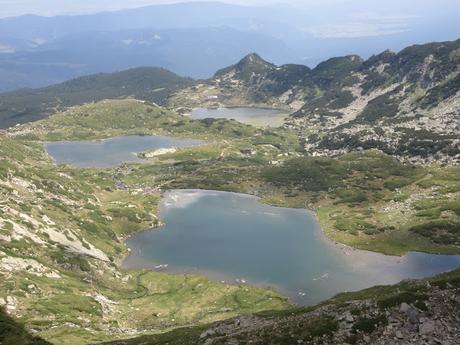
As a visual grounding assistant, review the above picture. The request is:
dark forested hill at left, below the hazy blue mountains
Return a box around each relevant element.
[0,67,193,128]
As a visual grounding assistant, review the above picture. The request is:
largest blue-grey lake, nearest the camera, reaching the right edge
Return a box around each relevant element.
[124,190,460,305]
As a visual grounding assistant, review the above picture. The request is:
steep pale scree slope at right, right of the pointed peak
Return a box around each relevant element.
[296,40,460,162]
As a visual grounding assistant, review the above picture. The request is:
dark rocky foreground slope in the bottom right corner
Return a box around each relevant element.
[195,287,460,345]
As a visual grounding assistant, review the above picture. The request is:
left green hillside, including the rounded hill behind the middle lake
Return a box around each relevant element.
[0,100,298,345]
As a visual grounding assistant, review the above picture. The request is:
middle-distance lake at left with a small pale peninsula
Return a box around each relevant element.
[44,135,203,168]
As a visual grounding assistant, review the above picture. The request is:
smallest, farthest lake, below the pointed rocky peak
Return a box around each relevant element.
[190,108,288,127]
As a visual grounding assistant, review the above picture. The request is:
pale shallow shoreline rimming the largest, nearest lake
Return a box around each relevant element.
[121,189,460,306]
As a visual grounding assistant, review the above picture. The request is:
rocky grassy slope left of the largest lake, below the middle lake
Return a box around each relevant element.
[0,132,288,344]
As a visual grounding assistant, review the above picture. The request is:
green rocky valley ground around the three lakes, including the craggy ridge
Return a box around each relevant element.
[0,41,460,345]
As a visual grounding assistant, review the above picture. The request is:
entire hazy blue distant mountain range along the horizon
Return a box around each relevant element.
[0,2,460,91]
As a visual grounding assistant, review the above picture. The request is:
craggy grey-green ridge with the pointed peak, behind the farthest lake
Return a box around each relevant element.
[169,40,460,162]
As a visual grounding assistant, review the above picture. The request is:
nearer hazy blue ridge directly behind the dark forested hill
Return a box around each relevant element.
[0,28,287,91]
